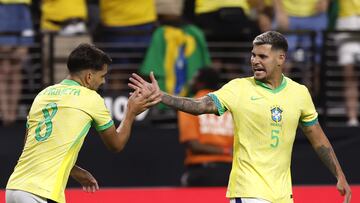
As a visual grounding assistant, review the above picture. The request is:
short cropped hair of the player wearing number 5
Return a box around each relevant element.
[253,31,288,52]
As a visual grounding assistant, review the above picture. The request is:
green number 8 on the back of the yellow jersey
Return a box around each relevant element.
[35,103,58,142]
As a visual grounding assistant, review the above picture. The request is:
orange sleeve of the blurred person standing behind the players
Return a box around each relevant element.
[178,112,200,143]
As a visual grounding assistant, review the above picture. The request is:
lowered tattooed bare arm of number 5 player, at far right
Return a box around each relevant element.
[302,123,351,203]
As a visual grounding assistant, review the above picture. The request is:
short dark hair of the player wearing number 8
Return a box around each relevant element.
[67,43,112,73]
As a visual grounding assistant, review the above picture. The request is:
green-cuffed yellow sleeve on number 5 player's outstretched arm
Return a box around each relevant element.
[208,80,240,115]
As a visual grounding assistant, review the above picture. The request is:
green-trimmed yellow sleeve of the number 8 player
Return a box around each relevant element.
[89,94,114,131]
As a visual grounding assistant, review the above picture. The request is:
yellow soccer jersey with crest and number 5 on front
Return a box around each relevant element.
[209,77,317,203]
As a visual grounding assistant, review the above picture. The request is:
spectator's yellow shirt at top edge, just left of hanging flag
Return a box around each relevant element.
[100,0,156,26]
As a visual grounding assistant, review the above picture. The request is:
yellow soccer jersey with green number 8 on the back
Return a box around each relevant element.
[6,80,113,203]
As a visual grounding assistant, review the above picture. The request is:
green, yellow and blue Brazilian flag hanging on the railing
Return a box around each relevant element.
[140,25,211,96]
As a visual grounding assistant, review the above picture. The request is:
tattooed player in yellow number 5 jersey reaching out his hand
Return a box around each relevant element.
[129,31,351,203]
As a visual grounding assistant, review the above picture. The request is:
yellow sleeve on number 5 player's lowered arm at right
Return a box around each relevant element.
[300,86,318,126]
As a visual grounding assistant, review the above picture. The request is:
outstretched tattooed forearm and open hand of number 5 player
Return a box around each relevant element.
[128,72,218,115]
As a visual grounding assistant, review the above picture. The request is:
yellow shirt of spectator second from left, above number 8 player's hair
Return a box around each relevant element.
[41,0,87,31]
